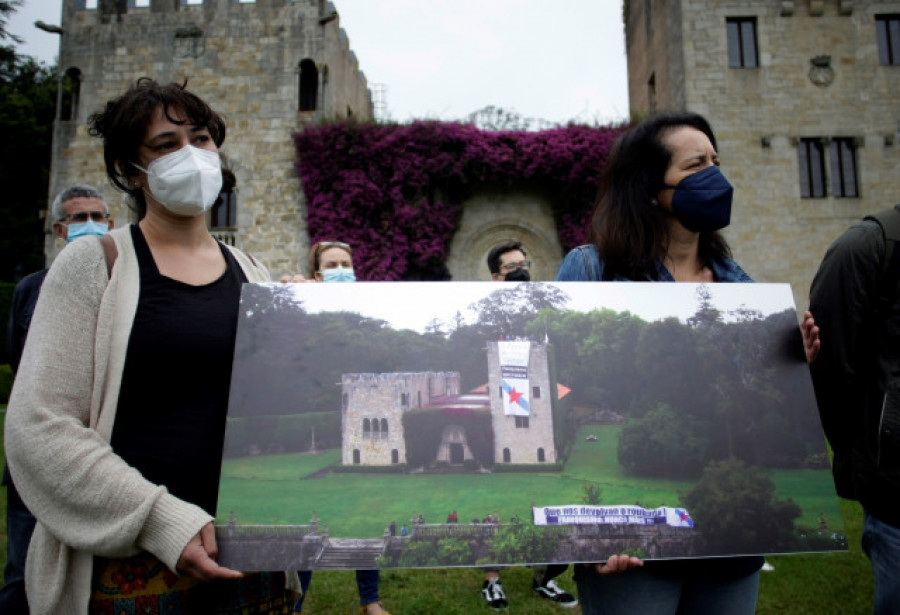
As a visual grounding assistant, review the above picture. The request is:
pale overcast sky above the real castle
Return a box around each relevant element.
[10,0,628,124]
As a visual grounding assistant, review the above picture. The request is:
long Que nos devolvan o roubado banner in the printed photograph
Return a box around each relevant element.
[531,504,694,527]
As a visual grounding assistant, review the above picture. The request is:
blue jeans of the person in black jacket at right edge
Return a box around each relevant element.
[862,509,900,615]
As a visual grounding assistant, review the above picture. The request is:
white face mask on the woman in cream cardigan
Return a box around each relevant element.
[134,145,222,217]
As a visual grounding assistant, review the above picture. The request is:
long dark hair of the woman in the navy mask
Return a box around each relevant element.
[588,113,731,279]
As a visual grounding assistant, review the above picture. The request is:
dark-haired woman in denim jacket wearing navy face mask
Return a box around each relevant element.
[556,113,763,615]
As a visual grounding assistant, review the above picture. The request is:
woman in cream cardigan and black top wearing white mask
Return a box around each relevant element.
[6,79,299,613]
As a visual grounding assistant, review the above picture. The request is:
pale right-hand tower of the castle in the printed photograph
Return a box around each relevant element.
[487,342,557,464]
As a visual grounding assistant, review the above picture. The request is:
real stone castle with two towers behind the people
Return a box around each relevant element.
[46,0,900,298]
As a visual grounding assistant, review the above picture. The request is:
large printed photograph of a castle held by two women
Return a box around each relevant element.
[216,282,847,570]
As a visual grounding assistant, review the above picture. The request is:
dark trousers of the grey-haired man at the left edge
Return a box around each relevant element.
[0,481,35,615]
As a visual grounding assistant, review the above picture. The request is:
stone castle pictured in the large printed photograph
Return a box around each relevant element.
[341,342,558,467]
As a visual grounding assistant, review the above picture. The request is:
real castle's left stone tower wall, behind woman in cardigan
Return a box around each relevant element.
[46,0,372,275]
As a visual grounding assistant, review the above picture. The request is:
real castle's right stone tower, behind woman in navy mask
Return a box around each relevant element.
[624,0,900,309]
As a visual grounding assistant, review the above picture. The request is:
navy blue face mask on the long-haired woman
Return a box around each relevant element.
[665,165,734,233]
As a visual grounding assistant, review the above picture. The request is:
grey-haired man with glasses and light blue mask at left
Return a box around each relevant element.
[0,185,113,615]
